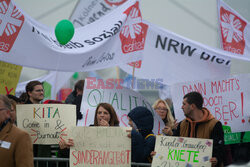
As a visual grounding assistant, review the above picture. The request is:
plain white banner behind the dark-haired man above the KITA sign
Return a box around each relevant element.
[15,71,73,101]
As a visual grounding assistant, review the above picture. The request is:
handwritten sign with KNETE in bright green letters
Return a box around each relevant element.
[152,136,213,167]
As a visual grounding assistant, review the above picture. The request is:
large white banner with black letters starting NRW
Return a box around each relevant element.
[120,21,250,85]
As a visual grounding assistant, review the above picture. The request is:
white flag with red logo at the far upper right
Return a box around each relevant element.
[217,0,250,55]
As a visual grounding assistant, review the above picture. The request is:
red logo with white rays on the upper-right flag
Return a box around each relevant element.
[220,7,247,54]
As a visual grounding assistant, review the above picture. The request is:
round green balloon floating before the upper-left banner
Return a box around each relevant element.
[55,20,75,45]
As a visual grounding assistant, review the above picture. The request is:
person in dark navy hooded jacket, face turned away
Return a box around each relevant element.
[128,107,155,163]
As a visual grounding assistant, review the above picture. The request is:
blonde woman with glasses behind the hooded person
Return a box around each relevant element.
[152,99,178,135]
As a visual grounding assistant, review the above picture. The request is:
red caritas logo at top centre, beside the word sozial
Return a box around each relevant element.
[120,2,148,53]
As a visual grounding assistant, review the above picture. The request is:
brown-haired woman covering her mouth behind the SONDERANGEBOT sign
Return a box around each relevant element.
[59,103,119,149]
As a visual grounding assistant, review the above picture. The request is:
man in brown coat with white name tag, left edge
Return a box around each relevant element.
[0,95,34,167]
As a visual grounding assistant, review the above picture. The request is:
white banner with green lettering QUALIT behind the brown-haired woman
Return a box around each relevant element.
[78,78,165,134]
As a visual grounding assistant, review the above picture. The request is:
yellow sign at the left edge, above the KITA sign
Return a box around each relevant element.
[0,61,22,95]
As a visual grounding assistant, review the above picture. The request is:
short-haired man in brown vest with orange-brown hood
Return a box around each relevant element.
[173,92,224,167]
